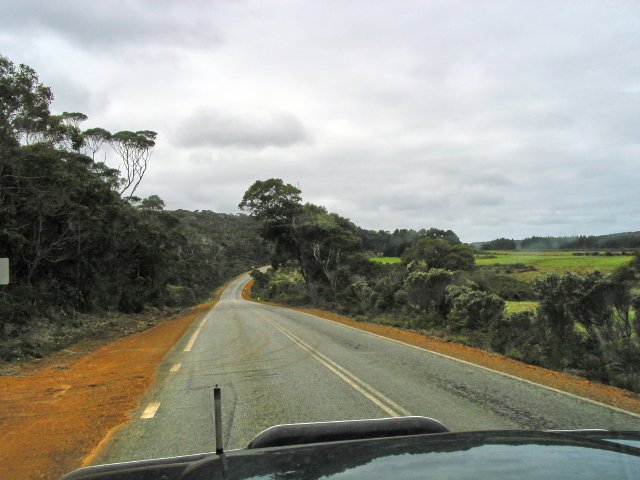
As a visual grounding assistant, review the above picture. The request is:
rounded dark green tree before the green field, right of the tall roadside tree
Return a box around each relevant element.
[402,236,475,270]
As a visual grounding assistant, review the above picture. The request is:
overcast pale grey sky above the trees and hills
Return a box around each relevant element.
[0,0,640,241]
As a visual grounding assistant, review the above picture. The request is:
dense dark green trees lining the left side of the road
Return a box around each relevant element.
[0,56,266,355]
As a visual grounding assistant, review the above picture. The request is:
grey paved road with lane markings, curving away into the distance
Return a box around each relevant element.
[96,276,640,463]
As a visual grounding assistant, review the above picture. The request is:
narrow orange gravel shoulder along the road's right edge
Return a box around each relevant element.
[242,281,640,414]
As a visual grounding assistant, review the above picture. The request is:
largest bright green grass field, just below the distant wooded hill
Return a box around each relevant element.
[476,251,633,281]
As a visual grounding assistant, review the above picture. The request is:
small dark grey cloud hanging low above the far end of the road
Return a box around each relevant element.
[173,110,311,149]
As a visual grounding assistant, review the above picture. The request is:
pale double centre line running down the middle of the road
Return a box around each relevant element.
[255,312,411,417]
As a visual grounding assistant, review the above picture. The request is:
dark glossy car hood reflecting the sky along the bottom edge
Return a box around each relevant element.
[63,431,640,480]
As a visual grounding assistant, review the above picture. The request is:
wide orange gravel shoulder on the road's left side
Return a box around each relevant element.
[0,292,222,480]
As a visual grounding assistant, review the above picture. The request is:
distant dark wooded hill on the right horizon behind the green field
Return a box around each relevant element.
[471,232,640,250]
